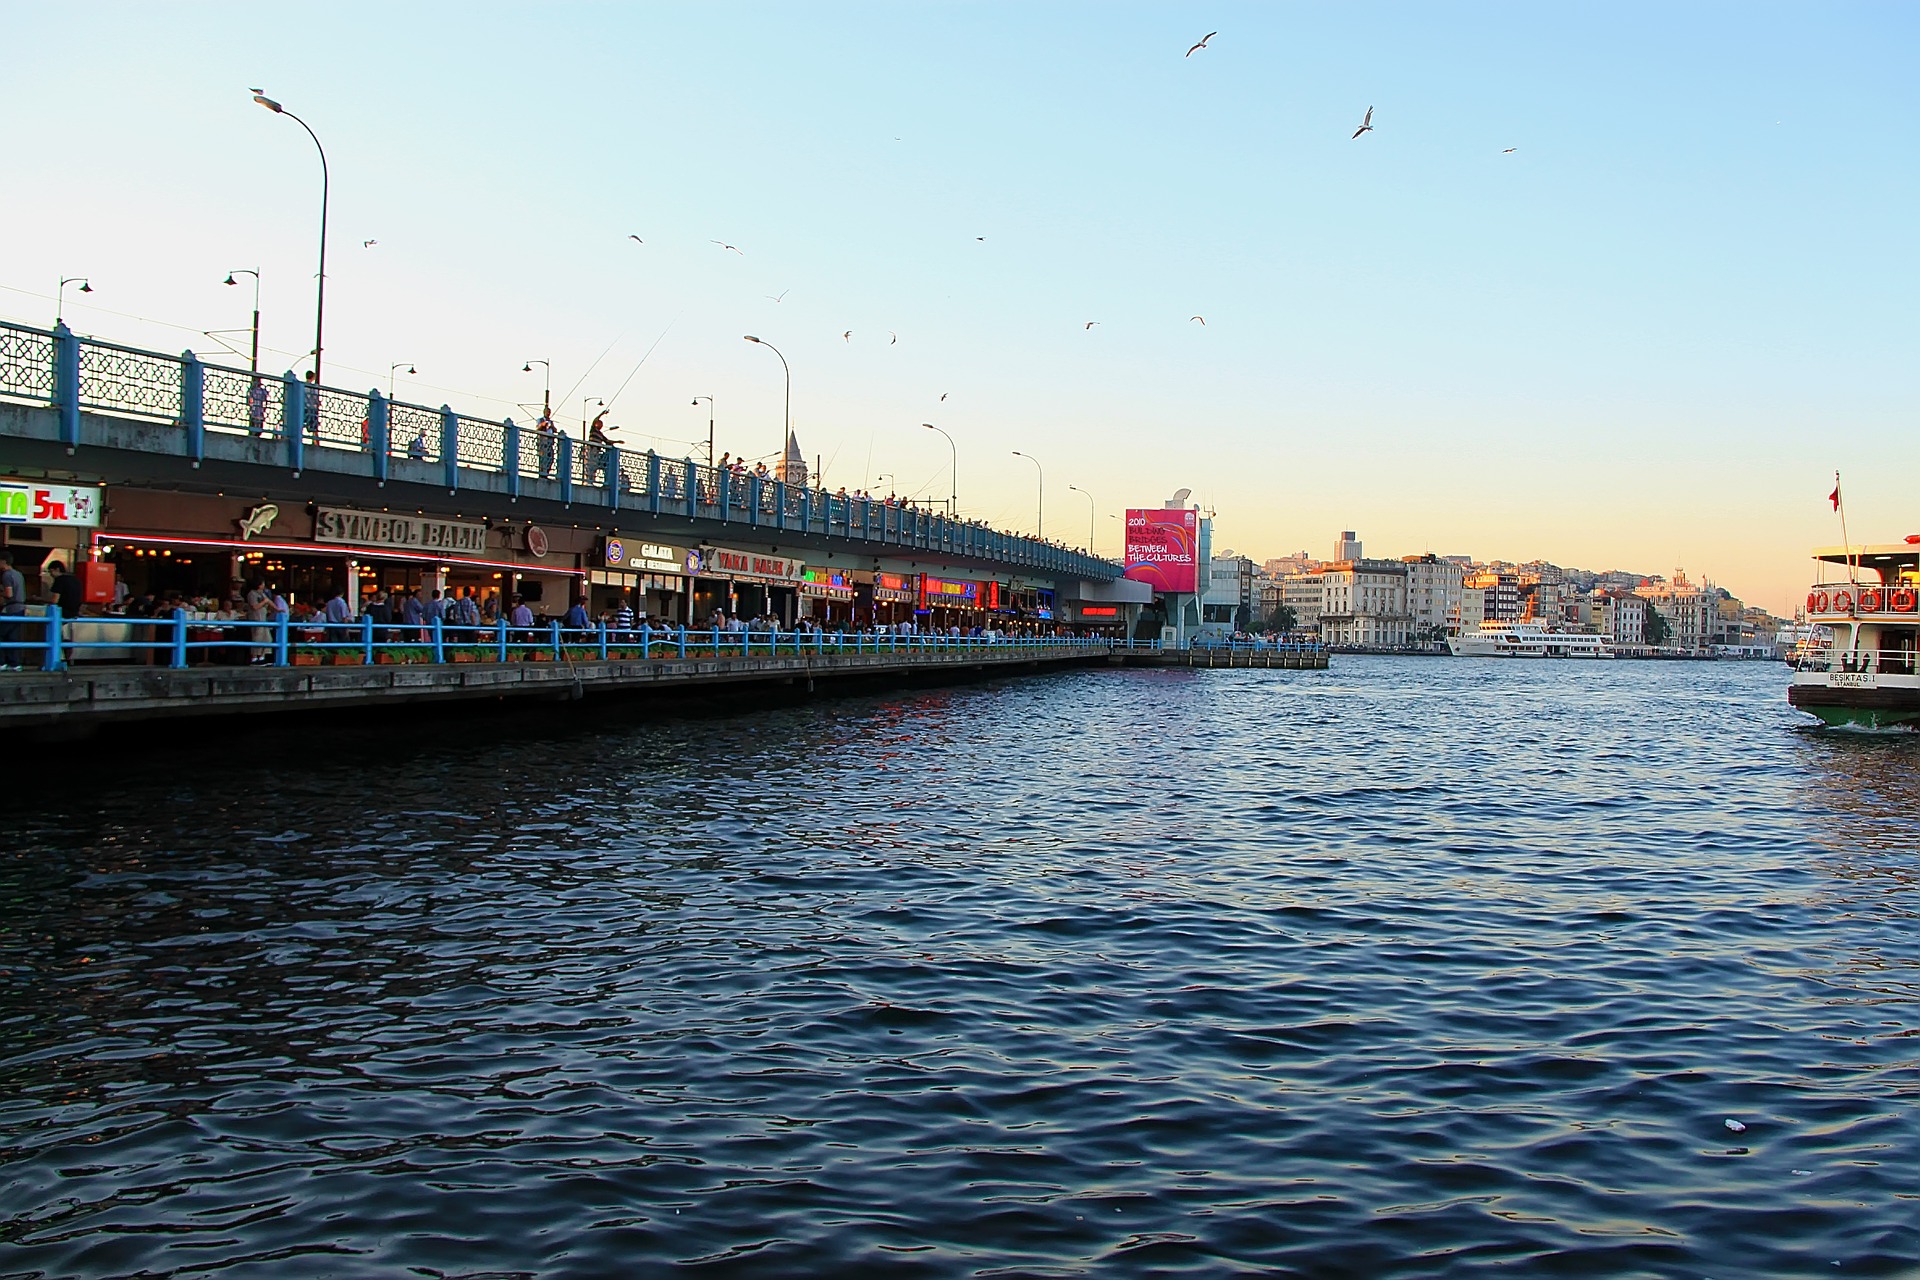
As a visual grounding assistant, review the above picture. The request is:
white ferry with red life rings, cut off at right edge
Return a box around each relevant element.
[1788,533,1920,729]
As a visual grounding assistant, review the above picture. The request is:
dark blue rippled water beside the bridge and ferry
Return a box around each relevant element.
[0,660,1920,1278]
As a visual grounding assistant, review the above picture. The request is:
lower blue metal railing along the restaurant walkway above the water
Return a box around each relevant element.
[0,604,1160,672]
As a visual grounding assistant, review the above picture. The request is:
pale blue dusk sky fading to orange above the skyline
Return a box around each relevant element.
[0,0,1920,610]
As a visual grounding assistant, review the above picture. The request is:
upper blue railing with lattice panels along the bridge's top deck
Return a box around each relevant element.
[0,320,1121,581]
